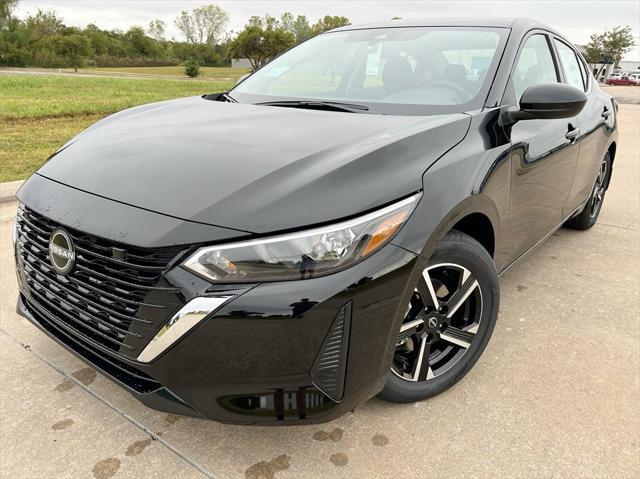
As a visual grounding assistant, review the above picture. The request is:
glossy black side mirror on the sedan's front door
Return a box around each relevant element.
[507,83,587,123]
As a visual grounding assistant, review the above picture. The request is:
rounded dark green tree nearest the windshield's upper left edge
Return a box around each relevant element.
[228,16,296,70]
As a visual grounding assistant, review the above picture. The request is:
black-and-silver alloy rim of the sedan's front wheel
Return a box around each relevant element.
[391,263,482,382]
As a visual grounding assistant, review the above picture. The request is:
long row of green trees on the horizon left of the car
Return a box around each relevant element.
[0,0,349,69]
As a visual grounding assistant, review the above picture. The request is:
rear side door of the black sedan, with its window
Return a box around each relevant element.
[553,37,614,216]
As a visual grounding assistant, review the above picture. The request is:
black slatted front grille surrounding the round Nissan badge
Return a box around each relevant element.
[16,205,184,357]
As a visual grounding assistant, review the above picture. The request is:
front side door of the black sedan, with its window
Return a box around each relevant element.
[503,31,579,257]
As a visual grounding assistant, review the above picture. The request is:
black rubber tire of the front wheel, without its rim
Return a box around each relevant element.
[379,231,500,402]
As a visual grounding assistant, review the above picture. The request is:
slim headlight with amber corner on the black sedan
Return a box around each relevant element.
[183,193,421,283]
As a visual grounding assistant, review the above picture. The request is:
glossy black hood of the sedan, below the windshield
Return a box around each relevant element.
[38,97,469,234]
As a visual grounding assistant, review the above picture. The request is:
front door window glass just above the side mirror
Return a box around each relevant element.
[513,35,558,101]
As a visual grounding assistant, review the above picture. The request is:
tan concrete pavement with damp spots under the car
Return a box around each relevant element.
[0,105,640,479]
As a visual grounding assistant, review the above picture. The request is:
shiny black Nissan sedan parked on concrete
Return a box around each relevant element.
[15,19,617,424]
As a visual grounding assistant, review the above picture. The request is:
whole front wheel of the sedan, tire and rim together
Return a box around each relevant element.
[378,231,500,403]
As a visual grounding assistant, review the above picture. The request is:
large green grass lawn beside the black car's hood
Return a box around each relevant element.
[0,75,234,182]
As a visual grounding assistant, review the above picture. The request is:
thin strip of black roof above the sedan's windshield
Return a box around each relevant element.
[331,17,558,33]
